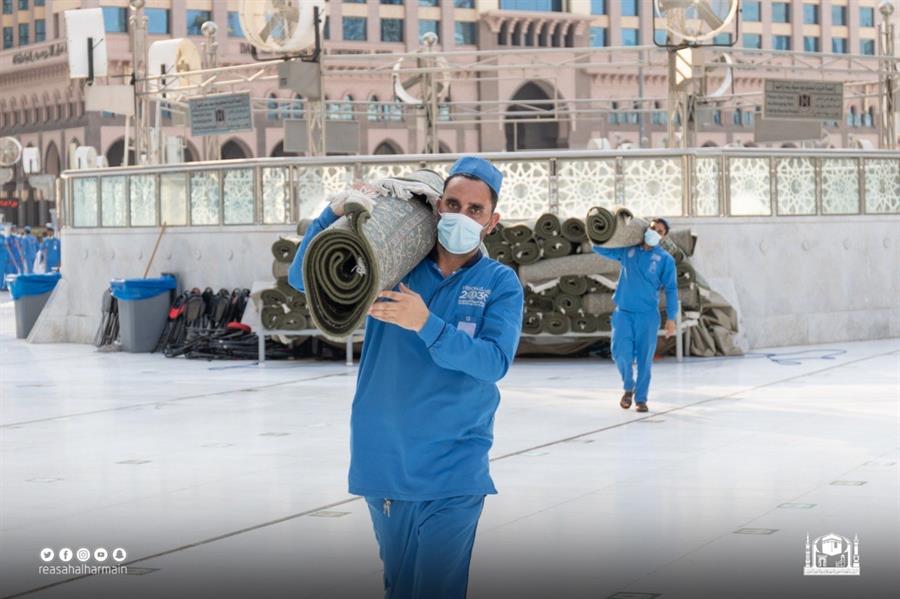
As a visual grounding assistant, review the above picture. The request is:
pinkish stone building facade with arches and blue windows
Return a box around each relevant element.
[0,0,897,224]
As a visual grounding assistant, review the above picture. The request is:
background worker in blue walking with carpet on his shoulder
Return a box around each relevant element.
[594,218,678,412]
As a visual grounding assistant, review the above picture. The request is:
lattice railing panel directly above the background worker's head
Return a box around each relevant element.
[622,158,684,217]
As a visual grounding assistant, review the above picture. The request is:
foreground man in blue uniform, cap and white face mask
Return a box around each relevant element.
[288,156,524,599]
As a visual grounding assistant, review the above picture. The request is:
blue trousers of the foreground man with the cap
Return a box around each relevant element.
[366,495,484,599]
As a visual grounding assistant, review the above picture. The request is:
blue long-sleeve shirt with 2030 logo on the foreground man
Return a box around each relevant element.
[288,208,524,501]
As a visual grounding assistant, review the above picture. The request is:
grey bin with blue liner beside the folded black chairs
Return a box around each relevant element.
[109,275,177,353]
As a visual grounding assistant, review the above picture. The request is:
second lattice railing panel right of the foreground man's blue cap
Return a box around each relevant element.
[556,160,616,218]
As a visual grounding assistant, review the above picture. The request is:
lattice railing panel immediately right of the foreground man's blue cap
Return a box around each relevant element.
[494,160,550,220]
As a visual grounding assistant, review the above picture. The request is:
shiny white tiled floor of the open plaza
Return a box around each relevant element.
[0,294,900,599]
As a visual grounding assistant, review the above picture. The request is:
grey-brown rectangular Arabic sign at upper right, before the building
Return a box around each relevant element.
[763,79,844,121]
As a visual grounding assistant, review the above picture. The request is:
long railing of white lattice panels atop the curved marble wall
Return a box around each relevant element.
[61,148,900,228]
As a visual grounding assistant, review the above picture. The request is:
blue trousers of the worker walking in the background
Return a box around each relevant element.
[612,308,659,403]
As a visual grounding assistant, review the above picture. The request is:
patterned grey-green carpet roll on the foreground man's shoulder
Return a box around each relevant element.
[303,169,442,340]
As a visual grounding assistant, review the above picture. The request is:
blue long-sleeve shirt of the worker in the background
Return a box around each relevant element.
[594,245,678,320]
